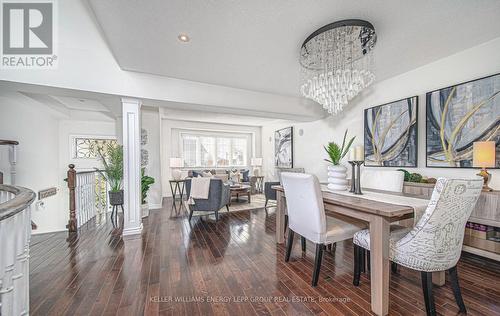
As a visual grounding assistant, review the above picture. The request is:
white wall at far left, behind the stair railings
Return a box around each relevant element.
[0,90,115,234]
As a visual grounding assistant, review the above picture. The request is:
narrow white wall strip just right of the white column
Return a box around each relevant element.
[141,109,162,209]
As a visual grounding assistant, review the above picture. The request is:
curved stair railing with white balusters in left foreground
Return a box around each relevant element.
[0,184,35,315]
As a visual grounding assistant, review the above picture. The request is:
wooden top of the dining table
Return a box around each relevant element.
[271,185,422,217]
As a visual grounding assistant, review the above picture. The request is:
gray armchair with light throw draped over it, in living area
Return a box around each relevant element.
[186,178,230,221]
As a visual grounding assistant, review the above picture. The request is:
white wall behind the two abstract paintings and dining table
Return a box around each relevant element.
[262,38,500,189]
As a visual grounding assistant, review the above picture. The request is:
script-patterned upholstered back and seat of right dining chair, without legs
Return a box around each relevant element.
[391,178,483,272]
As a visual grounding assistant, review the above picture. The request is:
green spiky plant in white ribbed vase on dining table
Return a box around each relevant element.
[324,130,356,191]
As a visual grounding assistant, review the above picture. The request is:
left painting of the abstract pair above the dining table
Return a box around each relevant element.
[364,96,418,167]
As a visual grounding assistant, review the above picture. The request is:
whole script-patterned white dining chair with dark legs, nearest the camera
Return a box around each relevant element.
[353,178,483,315]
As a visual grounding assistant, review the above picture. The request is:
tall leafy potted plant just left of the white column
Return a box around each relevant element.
[96,144,123,205]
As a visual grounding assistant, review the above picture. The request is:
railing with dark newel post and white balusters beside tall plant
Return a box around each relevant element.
[67,164,109,232]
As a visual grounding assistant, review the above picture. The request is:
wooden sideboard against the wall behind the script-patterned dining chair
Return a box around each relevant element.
[403,182,500,261]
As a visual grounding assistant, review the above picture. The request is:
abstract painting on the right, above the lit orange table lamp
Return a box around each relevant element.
[426,74,500,168]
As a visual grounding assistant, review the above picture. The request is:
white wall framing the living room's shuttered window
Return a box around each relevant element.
[161,118,262,197]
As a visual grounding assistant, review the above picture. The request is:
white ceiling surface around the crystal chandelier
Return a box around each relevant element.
[88,0,500,96]
